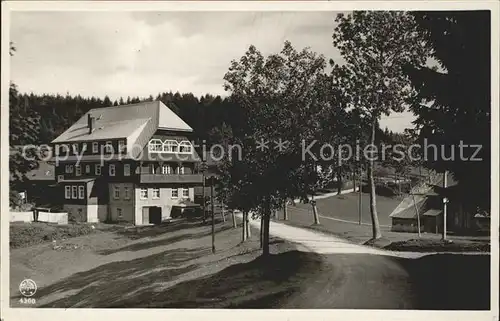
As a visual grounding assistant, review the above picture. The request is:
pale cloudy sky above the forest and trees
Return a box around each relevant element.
[11,11,414,131]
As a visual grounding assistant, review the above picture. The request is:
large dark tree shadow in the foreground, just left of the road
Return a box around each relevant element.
[105,251,321,308]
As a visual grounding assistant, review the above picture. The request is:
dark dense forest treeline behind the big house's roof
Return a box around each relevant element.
[10,85,245,146]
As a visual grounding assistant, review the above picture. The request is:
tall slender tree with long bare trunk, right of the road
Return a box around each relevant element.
[333,11,428,239]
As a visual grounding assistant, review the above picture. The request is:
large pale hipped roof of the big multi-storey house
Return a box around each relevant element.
[52,101,192,143]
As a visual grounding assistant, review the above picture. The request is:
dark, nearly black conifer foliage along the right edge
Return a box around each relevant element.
[407,11,491,212]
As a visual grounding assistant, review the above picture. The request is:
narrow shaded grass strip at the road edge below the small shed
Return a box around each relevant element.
[384,239,491,252]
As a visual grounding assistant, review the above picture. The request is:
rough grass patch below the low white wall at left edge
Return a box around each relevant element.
[9,222,97,249]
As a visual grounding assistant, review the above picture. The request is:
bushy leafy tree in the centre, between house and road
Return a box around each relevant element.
[225,42,331,255]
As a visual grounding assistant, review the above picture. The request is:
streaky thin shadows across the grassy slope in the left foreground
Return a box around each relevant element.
[32,248,210,308]
